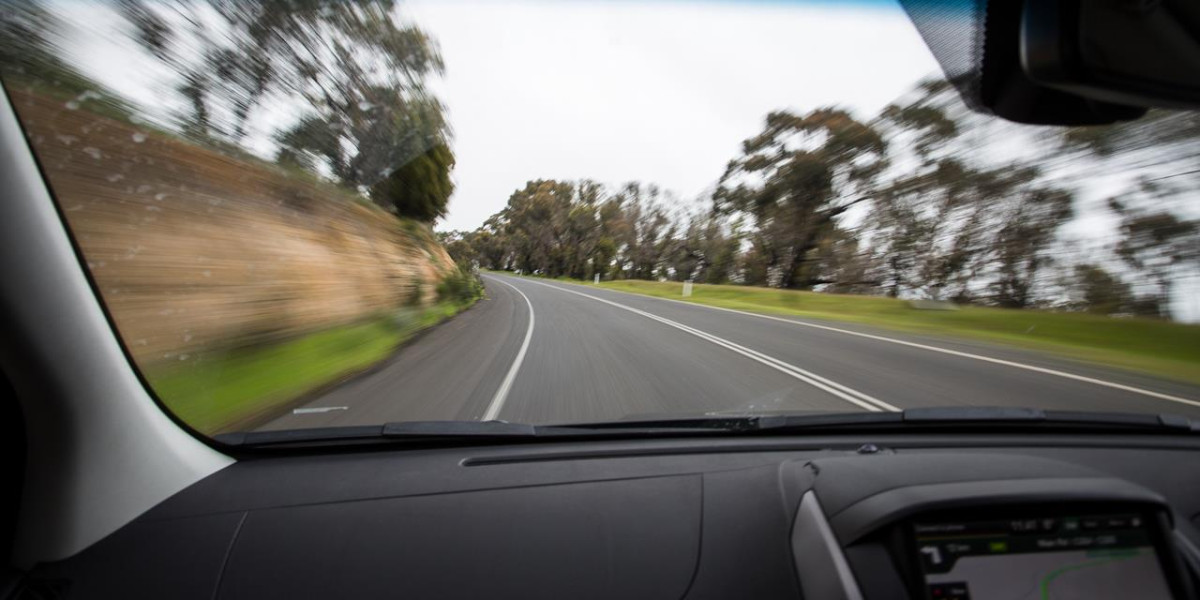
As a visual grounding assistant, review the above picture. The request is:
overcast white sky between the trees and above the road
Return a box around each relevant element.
[401,0,938,229]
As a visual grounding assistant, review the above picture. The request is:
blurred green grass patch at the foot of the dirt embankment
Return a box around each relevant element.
[145,302,470,436]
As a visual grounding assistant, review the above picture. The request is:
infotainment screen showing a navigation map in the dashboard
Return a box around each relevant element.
[913,512,1171,600]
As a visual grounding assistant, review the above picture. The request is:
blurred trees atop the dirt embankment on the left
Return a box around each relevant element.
[118,0,454,213]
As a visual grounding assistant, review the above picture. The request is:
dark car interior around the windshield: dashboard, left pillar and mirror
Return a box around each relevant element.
[0,0,1200,600]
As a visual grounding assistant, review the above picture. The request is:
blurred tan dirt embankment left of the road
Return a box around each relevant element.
[13,91,454,365]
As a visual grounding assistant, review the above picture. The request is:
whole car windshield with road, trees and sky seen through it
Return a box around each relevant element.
[0,0,1200,436]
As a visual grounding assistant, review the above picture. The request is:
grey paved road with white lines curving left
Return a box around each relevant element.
[262,275,1200,430]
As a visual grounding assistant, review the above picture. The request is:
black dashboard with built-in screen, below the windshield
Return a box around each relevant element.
[31,434,1200,600]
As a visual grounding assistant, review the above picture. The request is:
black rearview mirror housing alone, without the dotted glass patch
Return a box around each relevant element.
[1017,0,1200,109]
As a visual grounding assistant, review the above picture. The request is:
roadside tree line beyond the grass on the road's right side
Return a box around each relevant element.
[442,83,1200,318]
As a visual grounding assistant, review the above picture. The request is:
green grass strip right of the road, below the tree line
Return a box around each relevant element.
[513,274,1200,383]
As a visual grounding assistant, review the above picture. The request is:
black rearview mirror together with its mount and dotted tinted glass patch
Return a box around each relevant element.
[900,0,1200,125]
